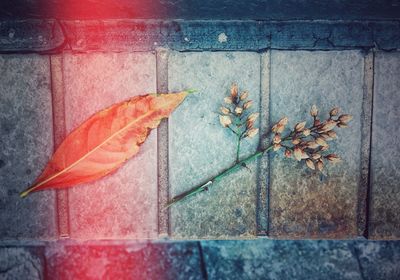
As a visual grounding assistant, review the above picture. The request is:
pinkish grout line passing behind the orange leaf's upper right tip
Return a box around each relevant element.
[156,48,169,238]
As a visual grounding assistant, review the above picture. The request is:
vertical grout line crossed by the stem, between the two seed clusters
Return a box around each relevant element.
[256,51,270,236]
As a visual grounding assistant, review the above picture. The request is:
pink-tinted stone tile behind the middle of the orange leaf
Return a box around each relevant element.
[64,53,157,239]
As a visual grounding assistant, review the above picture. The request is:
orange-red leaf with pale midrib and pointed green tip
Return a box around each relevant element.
[21,91,188,197]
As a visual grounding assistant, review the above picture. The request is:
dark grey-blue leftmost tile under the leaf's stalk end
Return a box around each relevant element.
[0,55,56,239]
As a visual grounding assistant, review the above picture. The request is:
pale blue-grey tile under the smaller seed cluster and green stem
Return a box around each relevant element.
[168,52,260,239]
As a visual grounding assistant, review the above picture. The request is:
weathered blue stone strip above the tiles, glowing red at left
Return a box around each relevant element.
[0,19,400,54]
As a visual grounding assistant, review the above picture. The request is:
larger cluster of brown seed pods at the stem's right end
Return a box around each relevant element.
[271,105,352,171]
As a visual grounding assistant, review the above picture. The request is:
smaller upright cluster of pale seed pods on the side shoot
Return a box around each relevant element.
[219,84,259,139]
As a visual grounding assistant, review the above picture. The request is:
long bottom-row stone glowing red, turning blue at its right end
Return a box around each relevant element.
[46,242,204,280]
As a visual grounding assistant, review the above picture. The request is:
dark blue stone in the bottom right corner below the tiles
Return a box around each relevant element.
[353,241,400,280]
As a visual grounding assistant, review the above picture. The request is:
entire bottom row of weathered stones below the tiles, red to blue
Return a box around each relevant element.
[0,239,400,280]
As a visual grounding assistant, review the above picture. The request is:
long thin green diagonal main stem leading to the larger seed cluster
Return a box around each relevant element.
[165,144,273,208]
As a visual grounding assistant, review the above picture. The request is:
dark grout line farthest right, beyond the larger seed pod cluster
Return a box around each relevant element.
[357,52,374,238]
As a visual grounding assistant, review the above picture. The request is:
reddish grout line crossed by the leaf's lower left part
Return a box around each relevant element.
[50,55,70,238]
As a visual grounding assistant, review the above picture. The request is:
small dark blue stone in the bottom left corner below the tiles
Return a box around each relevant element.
[0,247,45,280]
